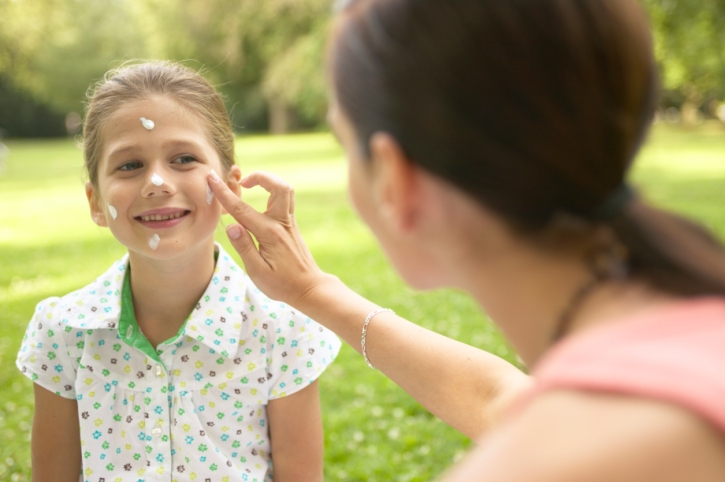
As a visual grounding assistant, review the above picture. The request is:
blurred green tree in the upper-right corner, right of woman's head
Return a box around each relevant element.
[641,0,725,122]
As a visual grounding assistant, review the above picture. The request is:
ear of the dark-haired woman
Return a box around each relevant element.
[370,132,421,232]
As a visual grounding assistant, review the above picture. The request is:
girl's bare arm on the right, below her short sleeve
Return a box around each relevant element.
[267,380,324,482]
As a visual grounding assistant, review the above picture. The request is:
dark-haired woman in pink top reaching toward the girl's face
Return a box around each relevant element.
[205,0,725,481]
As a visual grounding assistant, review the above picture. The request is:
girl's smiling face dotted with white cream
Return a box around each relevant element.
[86,96,241,259]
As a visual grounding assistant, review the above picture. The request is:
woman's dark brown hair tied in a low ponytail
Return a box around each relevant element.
[330,0,725,296]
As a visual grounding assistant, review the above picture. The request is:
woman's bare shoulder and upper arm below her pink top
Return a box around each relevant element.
[441,390,725,482]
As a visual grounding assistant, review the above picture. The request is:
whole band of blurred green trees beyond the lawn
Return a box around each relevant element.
[0,0,725,136]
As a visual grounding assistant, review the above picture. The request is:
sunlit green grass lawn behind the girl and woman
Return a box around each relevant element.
[0,124,725,481]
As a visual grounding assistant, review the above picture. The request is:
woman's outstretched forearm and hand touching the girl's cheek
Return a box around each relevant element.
[209,172,530,438]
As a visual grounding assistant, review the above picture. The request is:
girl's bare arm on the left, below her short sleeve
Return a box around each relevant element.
[31,383,82,482]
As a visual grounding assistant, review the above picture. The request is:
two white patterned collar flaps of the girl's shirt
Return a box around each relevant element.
[61,244,249,357]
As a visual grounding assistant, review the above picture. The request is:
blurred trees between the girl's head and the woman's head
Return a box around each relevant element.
[138,0,332,132]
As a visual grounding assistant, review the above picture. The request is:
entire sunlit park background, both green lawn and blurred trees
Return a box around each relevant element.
[0,0,725,481]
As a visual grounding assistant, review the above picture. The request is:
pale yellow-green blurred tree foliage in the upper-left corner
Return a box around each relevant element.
[0,0,147,135]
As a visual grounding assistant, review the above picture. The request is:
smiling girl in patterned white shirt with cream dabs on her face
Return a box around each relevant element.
[17,62,339,482]
